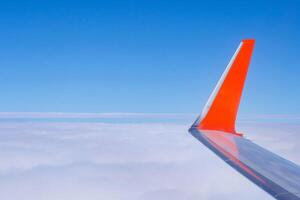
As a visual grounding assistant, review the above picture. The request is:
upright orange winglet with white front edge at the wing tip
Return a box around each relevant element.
[197,39,255,135]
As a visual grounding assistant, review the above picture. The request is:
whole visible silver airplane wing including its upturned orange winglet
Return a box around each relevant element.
[189,39,300,200]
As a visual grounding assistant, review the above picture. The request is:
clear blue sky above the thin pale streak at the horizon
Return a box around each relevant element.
[0,0,300,115]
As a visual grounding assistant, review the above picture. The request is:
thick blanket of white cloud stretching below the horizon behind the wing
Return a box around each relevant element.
[0,119,300,200]
